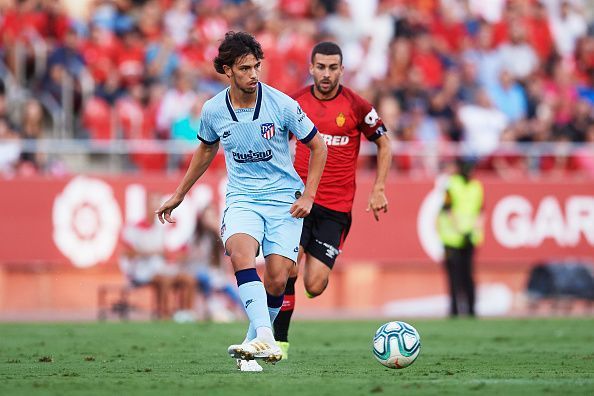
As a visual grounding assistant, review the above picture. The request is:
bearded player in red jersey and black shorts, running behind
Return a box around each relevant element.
[274,42,392,358]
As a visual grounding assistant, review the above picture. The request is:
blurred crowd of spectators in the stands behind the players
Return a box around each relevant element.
[0,0,594,176]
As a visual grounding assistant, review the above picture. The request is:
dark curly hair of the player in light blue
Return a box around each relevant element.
[214,31,264,74]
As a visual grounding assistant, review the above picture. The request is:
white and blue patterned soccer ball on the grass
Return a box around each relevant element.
[373,321,421,368]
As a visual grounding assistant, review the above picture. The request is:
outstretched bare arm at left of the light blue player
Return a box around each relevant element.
[155,141,219,224]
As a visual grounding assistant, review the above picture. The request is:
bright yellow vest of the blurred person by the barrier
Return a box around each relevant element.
[437,175,483,248]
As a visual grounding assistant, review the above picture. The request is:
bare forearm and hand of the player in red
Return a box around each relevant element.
[367,134,392,221]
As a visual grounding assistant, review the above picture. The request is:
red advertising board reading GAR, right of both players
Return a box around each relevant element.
[344,178,594,264]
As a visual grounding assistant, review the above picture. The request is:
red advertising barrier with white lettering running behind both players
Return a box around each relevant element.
[0,173,594,267]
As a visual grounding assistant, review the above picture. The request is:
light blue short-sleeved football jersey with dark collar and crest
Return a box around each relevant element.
[198,82,317,204]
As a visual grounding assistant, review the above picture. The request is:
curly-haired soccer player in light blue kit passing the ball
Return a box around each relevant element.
[156,32,326,371]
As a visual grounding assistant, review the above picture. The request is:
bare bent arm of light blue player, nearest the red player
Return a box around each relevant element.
[290,133,328,218]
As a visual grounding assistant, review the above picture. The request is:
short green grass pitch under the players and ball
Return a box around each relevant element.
[0,318,594,396]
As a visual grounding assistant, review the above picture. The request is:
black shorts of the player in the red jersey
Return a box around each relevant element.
[300,204,352,269]
